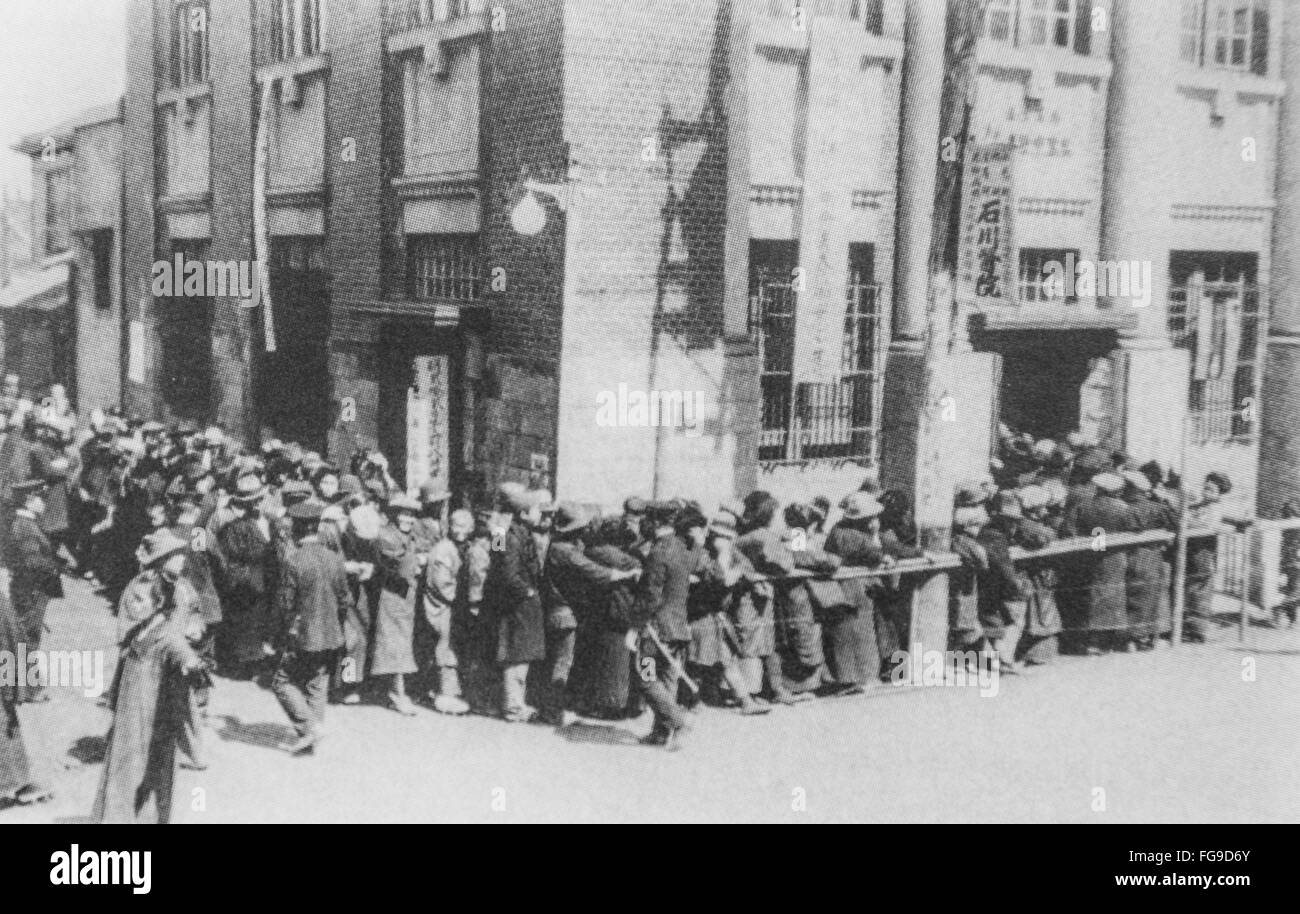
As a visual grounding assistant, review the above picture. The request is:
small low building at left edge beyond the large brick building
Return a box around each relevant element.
[0,103,124,410]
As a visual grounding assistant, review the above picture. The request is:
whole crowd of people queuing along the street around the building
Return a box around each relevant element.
[0,374,1248,822]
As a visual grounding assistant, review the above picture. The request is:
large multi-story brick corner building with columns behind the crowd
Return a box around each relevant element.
[114,0,1284,533]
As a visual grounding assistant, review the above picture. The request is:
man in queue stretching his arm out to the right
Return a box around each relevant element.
[540,502,637,727]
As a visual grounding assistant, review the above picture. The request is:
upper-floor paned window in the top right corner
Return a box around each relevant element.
[1178,0,1270,77]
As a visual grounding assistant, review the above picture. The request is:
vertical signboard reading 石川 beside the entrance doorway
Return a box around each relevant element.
[957,143,1017,311]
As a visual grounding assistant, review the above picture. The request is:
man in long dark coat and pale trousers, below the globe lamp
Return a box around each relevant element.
[484,489,546,723]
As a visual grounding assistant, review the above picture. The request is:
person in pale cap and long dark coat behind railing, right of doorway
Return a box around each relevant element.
[1078,472,1139,654]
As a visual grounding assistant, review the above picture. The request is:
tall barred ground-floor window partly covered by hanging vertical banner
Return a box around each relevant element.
[750,241,887,463]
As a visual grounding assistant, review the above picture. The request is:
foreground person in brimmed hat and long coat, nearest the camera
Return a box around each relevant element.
[92,529,205,824]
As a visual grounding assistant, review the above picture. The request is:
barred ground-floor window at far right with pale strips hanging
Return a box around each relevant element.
[1169,252,1266,443]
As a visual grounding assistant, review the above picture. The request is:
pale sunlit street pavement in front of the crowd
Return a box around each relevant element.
[0,582,1300,823]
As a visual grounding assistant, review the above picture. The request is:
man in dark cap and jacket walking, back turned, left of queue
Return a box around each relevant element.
[270,501,352,755]
